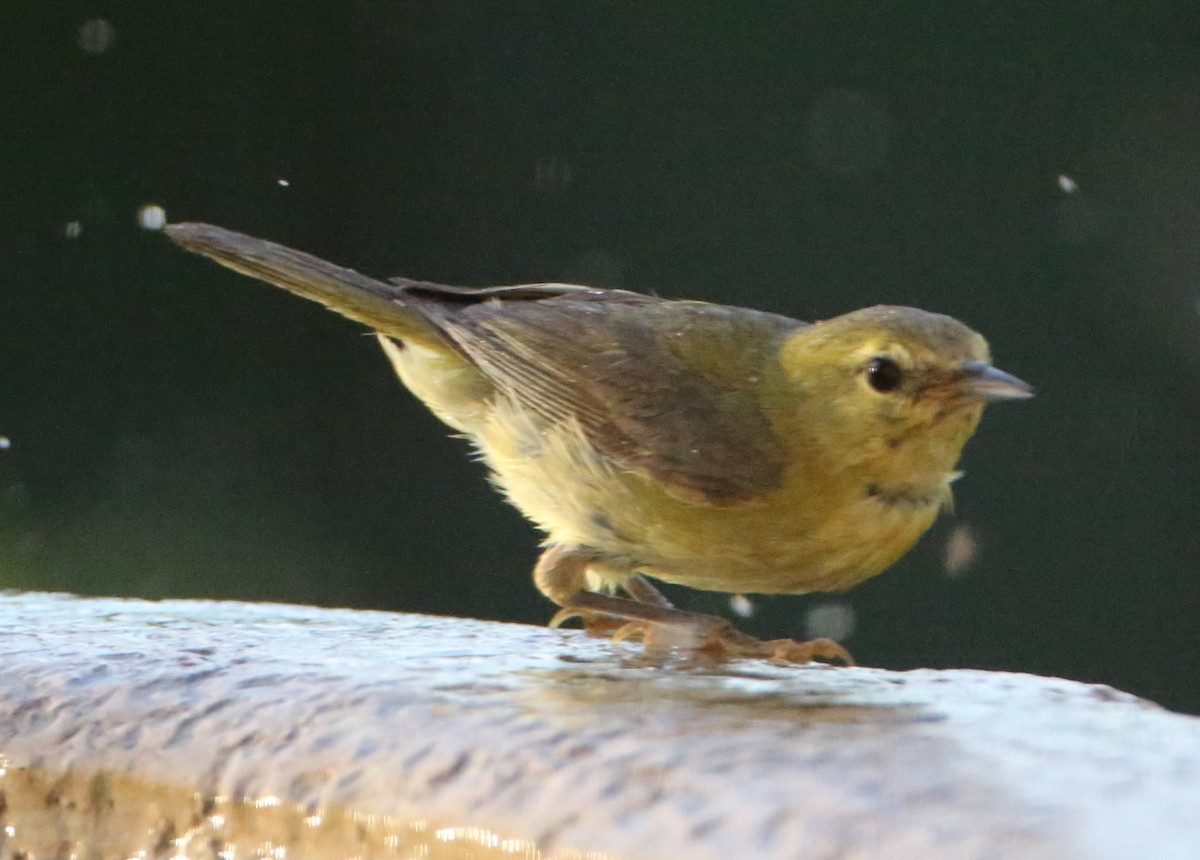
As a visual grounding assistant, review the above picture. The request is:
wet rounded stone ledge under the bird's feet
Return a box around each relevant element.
[0,594,1200,860]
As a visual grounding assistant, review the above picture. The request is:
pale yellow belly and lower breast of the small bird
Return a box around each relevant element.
[476,398,940,594]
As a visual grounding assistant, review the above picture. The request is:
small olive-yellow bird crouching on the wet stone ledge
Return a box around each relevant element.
[166,222,1033,664]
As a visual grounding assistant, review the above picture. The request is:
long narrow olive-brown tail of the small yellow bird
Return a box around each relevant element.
[166,223,446,348]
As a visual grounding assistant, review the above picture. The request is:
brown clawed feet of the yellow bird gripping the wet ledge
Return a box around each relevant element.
[550,591,854,666]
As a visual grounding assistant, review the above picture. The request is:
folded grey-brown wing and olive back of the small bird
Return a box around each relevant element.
[440,295,800,504]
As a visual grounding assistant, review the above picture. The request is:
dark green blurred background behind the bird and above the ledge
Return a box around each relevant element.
[0,0,1200,711]
